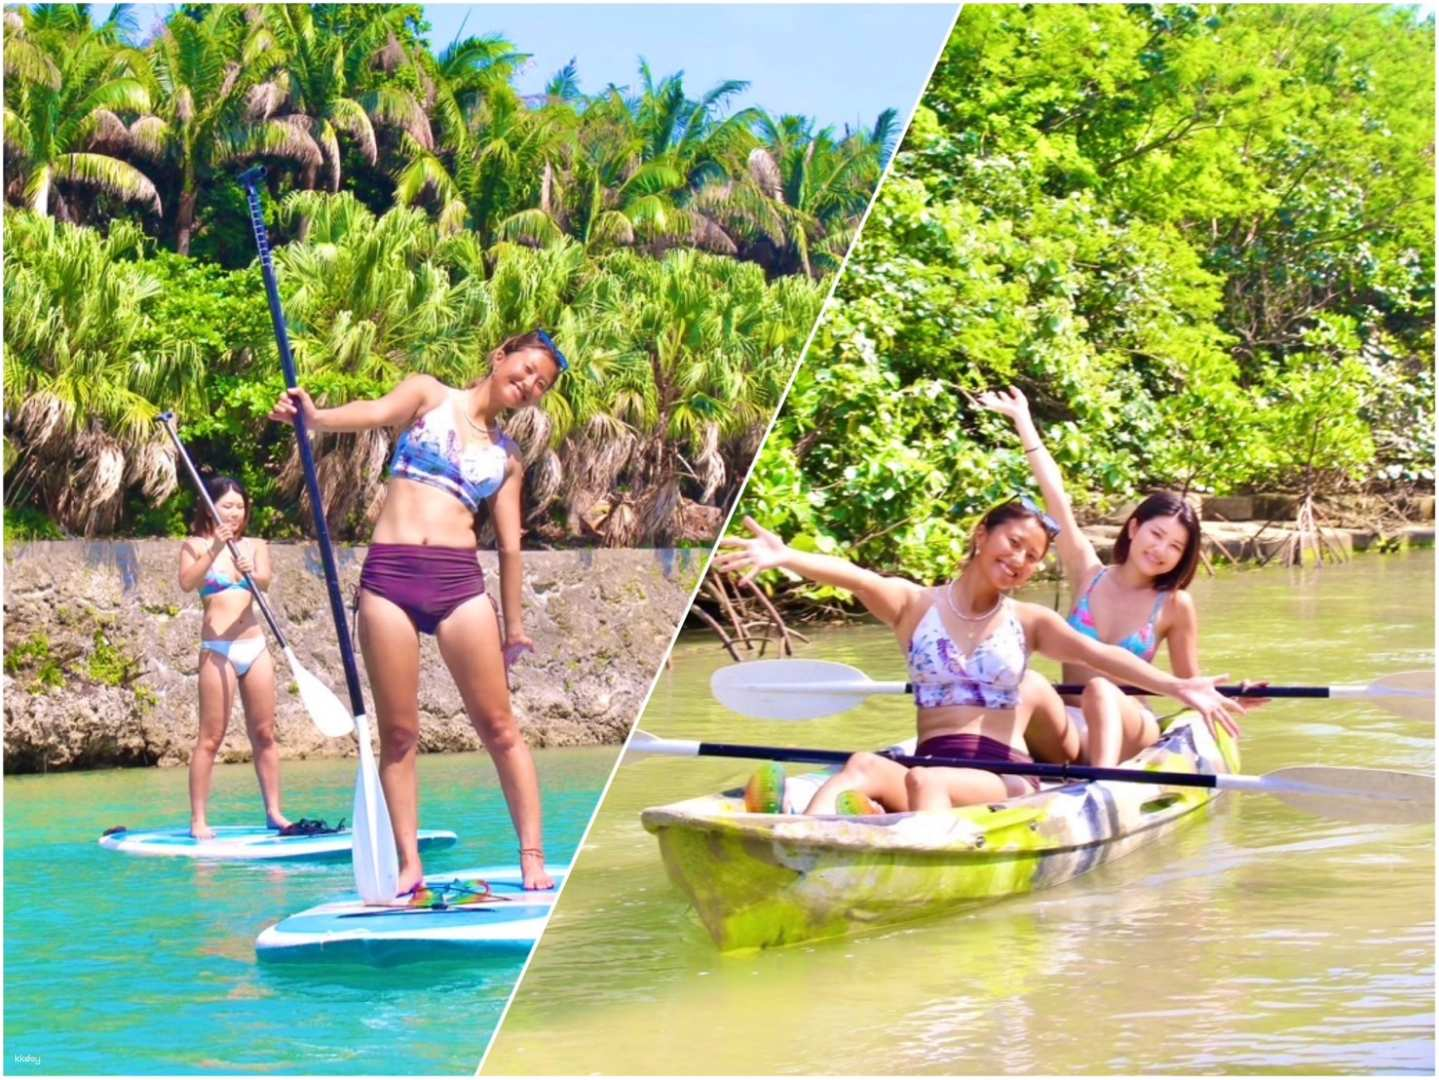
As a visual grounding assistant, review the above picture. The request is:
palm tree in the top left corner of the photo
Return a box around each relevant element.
[4,4,160,220]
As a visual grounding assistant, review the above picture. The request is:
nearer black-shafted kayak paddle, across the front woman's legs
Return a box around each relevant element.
[626,729,1435,825]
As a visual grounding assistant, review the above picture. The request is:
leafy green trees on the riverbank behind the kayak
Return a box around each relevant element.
[745,4,1435,592]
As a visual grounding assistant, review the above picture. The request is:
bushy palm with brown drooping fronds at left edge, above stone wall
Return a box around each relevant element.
[4,210,204,535]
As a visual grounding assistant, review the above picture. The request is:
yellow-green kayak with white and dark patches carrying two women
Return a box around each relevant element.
[640,713,1239,951]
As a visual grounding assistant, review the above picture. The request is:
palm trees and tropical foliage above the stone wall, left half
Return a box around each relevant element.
[4,4,869,544]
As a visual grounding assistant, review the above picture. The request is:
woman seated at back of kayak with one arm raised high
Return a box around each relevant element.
[979,387,1200,765]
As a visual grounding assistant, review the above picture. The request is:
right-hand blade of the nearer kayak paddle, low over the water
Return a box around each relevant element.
[1220,765,1435,825]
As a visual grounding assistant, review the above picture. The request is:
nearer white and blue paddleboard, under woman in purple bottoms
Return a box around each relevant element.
[255,866,570,964]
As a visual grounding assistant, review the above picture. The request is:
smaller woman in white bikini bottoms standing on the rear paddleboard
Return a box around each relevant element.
[180,476,289,840]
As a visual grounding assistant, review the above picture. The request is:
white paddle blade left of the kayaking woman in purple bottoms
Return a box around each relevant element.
[709,660,904,720]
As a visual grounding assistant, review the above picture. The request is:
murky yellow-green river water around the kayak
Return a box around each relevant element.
[485,552,1435,1074]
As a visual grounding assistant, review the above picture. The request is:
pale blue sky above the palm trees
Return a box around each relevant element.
[92,4,957,127]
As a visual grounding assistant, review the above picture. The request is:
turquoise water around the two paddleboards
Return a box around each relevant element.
[4,748,614,1074]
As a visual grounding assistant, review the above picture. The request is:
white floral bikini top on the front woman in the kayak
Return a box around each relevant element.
[909,598,1029,709]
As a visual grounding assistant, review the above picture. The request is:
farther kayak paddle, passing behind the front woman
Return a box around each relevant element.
[709,660,1435,720]
